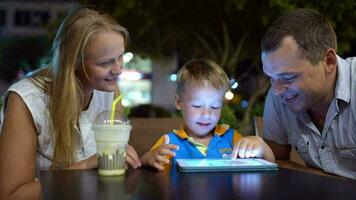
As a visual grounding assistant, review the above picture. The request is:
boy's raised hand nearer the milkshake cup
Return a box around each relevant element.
[141,144,179,170]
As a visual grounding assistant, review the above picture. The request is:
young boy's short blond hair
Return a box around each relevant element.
[177,59,230,95]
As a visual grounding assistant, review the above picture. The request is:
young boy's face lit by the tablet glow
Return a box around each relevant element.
[176,85,225,137]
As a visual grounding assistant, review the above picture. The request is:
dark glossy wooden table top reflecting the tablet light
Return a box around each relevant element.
[40,167,356,200]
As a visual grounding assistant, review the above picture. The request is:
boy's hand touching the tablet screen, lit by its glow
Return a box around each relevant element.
[232,136,274,162]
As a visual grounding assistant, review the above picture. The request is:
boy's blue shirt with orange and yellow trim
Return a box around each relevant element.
[151,124,242,164]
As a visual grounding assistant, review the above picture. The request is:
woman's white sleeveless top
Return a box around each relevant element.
[0,79,114,170]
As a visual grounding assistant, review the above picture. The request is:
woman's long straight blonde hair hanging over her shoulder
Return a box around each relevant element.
[31,8,129,168]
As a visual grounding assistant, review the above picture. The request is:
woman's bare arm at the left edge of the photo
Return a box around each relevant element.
[0,92,42,199]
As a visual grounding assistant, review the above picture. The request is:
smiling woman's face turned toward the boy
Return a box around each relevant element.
[77,31,125,93]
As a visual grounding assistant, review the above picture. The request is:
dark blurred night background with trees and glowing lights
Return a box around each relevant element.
[0,0,356,133]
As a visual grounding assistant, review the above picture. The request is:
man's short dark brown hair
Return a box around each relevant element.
[261,9,337,64]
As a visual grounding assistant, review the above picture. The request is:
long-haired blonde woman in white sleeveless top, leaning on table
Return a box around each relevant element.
[0,8,141,199]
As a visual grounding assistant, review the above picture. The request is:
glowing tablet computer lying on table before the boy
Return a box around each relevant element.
[177,158,278,172]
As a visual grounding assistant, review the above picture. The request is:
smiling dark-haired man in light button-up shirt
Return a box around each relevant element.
[261,9,356,179]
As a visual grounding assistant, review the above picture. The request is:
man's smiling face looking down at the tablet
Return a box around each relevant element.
[262,37,328,112]
